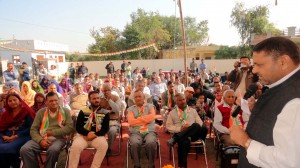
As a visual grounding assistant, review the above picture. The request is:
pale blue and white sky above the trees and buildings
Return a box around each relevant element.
[0,0,300,52]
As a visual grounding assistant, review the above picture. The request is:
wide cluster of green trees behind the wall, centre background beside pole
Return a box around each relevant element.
[86,9,208,60]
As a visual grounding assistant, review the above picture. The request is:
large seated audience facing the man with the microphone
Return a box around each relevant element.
[0,58,262,168]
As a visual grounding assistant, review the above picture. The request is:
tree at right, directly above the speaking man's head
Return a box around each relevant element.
[231,3,281,46]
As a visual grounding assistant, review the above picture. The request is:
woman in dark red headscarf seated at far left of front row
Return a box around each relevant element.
[0,94,35,168]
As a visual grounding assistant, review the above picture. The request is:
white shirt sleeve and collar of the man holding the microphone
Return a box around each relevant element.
[246,67,300,168]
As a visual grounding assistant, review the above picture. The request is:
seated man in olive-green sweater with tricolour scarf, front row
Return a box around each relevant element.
[20,92,73,168]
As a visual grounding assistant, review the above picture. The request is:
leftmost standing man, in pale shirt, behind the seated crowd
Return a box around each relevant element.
[3,62,20,90]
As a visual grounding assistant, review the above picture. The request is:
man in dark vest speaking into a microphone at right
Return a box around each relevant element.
[229,37,300,168]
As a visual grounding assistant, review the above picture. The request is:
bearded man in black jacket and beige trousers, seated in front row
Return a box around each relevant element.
[69,91,109,168]
